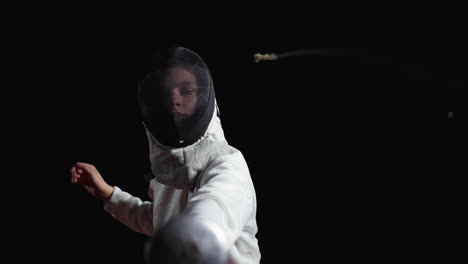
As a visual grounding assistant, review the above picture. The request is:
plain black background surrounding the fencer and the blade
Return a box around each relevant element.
[0,2,468,263]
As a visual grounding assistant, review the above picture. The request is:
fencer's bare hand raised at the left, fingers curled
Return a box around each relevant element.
[70,162,114,201]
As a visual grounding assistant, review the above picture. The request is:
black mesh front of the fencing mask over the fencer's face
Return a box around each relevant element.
[139,47,215,148]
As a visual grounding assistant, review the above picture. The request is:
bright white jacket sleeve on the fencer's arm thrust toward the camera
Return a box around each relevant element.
[185,156,255,248]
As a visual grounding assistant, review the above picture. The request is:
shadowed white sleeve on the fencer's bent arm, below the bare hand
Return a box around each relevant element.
[104,186,153,236]
